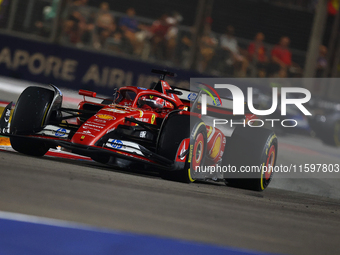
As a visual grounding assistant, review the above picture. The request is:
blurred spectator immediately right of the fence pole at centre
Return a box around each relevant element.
[198,17,218,72]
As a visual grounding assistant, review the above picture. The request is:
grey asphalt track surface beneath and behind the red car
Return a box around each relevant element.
[0,77,340,254]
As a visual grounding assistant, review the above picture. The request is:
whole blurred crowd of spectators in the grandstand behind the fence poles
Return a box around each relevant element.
[55,0,327,77]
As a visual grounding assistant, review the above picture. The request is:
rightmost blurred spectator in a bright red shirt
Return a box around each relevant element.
[271,36,292,78]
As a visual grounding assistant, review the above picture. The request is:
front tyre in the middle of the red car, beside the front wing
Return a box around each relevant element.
[158,114,207,183]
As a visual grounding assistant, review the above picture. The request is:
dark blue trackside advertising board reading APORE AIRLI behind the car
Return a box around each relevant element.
[0,34,202,94]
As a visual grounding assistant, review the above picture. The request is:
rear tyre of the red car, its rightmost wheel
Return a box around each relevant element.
[222,127,277,191]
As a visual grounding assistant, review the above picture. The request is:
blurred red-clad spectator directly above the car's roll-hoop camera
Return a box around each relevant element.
[150,14,171,60]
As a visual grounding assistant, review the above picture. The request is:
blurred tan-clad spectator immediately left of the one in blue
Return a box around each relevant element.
[93,2,121,49]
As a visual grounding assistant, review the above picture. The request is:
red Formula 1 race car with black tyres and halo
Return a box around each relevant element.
[0,70,277,191]
